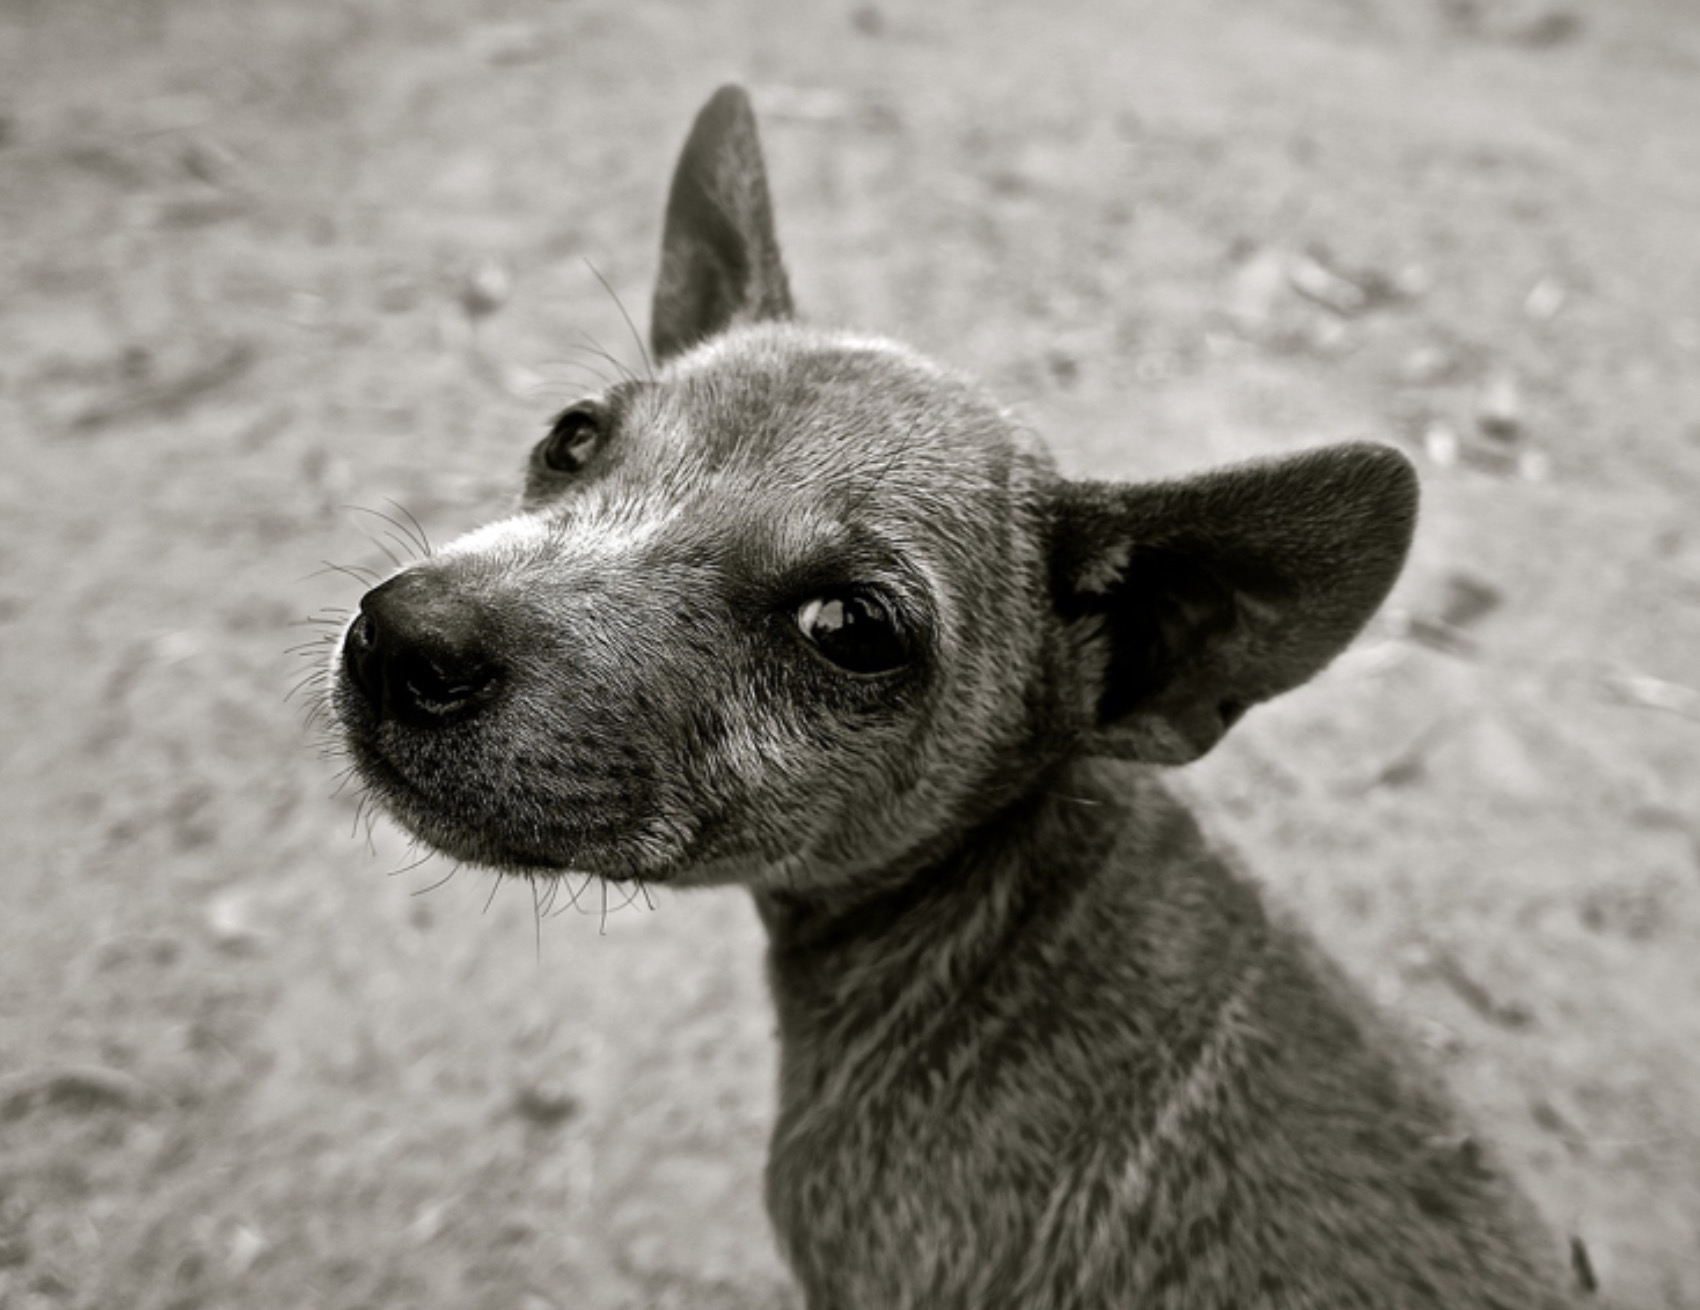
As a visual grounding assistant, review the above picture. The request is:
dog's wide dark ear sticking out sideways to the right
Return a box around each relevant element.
[1051,445,1416,765]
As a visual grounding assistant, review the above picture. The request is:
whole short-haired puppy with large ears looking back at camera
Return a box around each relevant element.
[333,87,1571,1310]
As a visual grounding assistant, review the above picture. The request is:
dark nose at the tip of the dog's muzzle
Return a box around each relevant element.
[342,569,502,727]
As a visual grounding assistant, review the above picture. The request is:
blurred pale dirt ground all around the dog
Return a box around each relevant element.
[0,0,1700,1310]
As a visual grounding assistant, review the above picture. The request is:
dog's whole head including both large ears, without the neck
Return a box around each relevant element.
[333,88,1416,890]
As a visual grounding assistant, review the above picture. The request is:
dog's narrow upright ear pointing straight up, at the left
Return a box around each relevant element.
[649,87,792,360]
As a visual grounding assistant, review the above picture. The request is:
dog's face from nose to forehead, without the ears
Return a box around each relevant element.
[335,325,1051,889]
